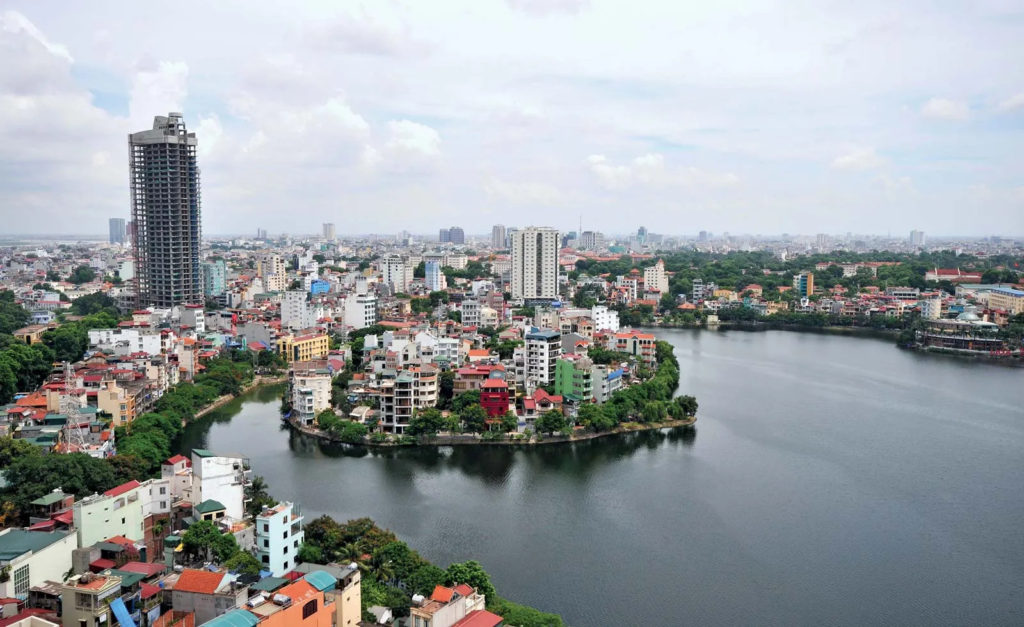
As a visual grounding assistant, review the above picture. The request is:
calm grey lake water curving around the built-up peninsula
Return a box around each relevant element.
[185,331,1024,627]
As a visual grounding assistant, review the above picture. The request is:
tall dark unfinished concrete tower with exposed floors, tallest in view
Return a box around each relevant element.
[128,113,203,307]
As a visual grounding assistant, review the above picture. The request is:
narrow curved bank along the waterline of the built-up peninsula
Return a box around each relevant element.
[285,416,697,449]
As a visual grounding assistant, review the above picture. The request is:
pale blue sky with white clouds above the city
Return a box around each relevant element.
[0,0,1024,236]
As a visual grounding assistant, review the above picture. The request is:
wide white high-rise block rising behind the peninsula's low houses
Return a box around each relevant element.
[512,226,559,299]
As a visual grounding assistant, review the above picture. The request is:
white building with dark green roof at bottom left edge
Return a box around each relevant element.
[0,529,78,598]
